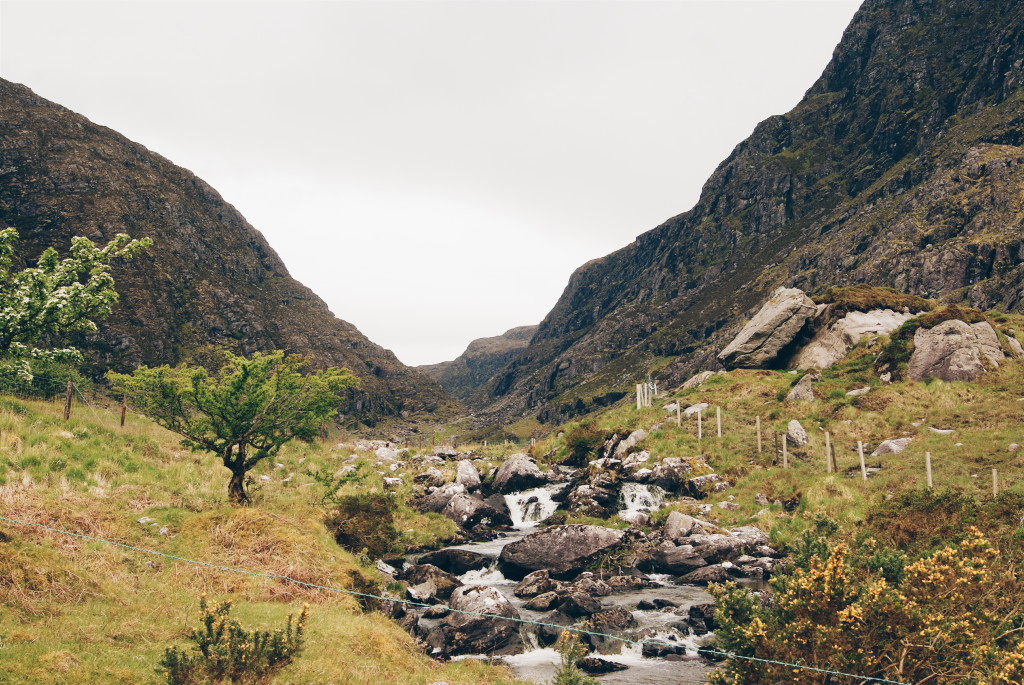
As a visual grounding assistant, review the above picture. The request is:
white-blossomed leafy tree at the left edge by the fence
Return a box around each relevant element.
[0,228,153,376]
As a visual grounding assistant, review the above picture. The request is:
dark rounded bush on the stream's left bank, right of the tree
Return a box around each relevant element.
[325,493,398,559]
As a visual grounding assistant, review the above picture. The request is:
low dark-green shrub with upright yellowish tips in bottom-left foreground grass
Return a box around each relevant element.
[157,595,309,685]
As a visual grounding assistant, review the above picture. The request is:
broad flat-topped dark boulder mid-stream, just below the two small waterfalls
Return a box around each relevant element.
[499,524,624,579]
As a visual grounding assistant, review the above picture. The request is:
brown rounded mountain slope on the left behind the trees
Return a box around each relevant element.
[0,80,455,422]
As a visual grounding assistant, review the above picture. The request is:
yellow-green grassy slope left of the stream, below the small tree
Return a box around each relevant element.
[0,398,520,685]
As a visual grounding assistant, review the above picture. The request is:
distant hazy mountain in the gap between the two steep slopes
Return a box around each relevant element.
[417,326,537,400]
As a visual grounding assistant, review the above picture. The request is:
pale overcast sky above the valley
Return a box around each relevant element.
[0,0,860,365]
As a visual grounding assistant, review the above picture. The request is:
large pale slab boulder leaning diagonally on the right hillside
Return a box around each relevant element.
[718,288,817,369]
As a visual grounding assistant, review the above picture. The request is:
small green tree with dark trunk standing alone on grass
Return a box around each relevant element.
[109,350,357,504]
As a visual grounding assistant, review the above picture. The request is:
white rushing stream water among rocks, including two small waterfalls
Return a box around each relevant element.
[436,484,714,685]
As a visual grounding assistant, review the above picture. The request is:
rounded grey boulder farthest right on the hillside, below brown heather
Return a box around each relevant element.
[907,319,1006,381]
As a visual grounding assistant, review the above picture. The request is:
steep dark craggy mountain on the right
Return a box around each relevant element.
[477,0,1024,422]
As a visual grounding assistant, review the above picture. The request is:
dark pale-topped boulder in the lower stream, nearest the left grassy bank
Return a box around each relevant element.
[427,586,521,657]
